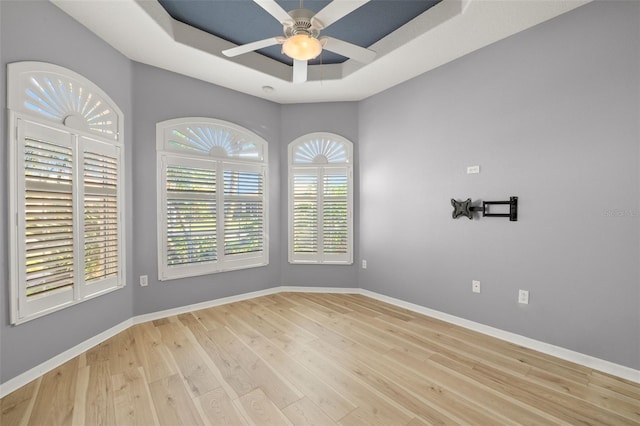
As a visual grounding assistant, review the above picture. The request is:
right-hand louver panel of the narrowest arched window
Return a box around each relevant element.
[322,174,349,254]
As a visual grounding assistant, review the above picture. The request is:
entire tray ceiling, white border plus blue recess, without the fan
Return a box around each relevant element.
[51,0,591,103]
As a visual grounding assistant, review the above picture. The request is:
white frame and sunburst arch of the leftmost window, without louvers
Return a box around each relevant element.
[7,61,126,324]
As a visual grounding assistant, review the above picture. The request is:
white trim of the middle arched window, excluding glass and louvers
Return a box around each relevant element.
[156,117,269,281]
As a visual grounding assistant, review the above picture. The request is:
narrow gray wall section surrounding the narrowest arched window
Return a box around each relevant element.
[280,102,359,287]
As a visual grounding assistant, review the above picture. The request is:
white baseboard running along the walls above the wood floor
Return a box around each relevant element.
[0,286,640,398]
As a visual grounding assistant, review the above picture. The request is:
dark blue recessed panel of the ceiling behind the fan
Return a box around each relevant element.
[159,0,441,65]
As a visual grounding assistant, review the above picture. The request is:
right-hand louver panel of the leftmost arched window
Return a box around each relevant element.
[84,152,119,283]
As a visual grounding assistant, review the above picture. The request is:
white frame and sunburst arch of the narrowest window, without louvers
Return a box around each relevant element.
[288,132,353,265]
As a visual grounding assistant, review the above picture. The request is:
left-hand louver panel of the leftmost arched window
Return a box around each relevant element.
[24,138,74,297]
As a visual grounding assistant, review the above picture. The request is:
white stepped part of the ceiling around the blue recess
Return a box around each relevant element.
[51,0,591,103]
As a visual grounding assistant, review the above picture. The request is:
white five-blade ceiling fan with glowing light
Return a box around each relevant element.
[222,0,376,83]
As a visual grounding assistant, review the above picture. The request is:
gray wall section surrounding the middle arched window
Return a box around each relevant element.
[133,63,282,315]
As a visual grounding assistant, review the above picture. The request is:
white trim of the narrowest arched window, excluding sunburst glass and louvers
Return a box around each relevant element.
[287,132,354,265]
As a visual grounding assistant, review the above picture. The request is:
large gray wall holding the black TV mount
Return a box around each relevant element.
[359,2,640,369]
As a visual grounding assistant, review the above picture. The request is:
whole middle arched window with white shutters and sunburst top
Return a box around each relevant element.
[156,117,268,280]
